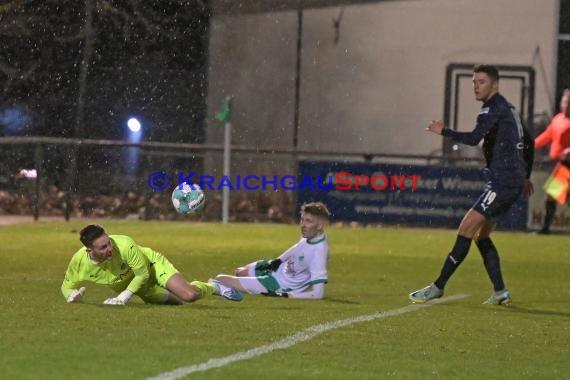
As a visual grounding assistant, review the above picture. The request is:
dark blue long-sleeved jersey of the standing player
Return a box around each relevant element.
[442,93,532,187]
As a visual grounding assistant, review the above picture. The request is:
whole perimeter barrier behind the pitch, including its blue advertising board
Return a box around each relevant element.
[0,137,552,230]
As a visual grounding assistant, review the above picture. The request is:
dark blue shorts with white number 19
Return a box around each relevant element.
[472,182,523,219]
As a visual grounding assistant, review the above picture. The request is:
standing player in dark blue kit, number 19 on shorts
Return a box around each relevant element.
[409,65,534,305]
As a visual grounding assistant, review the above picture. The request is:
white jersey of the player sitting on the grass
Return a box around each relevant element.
[271,234,329,294]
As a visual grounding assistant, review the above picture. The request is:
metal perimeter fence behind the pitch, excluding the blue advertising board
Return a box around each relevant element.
[0,137,512,223]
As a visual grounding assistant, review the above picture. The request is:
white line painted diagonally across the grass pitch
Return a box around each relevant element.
[147,294,468,380]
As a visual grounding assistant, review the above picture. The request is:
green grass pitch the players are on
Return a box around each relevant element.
[0,221,570,380]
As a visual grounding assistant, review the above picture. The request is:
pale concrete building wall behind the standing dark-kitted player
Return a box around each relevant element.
[207,0,557,154]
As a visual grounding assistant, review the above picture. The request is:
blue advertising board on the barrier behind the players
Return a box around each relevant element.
[297,161,528,229]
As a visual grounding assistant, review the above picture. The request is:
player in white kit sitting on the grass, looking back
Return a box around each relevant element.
[216,202,330,300]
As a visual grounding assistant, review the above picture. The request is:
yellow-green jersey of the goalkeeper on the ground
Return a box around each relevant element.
[61,235,171,299]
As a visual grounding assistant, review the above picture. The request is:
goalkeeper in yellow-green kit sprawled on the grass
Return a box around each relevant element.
[61,224,243,305]
